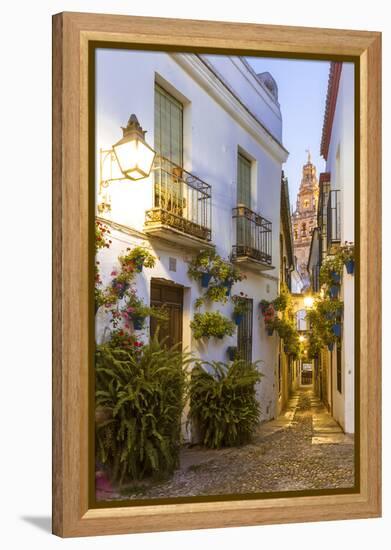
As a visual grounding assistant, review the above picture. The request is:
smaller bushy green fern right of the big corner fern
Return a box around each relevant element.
[190,360,262,449]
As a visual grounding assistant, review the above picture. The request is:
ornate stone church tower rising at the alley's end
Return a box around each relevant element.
[292,151,319,287]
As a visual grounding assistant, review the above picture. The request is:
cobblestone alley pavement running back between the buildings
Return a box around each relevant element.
[103,389,354,499]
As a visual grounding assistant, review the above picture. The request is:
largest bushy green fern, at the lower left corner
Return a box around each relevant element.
[96,335,192,484]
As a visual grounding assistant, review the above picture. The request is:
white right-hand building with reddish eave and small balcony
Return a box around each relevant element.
[319,63,355,433]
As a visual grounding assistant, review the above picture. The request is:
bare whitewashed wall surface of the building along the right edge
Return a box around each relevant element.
[326,63,355,433]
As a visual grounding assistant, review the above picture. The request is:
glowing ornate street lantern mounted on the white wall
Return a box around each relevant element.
[113,114,155,180]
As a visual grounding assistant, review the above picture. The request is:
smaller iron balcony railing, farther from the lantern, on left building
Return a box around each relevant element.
[232,205,272,266]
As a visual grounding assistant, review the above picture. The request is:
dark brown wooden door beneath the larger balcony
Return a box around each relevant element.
[150,281,183,347]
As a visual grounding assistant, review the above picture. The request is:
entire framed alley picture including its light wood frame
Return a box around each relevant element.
[53,13,381,537]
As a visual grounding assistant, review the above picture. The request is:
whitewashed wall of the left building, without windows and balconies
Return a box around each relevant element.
[96,50,286,419]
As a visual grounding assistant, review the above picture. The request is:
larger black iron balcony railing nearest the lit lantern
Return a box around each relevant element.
[145,157,212,241]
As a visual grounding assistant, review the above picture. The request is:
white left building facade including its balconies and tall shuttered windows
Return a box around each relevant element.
[96,49,288,426]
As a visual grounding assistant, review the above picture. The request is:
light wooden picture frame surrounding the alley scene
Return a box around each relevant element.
[53,13,381,537]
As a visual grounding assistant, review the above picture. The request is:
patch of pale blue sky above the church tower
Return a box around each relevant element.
[247,57,330,207]
